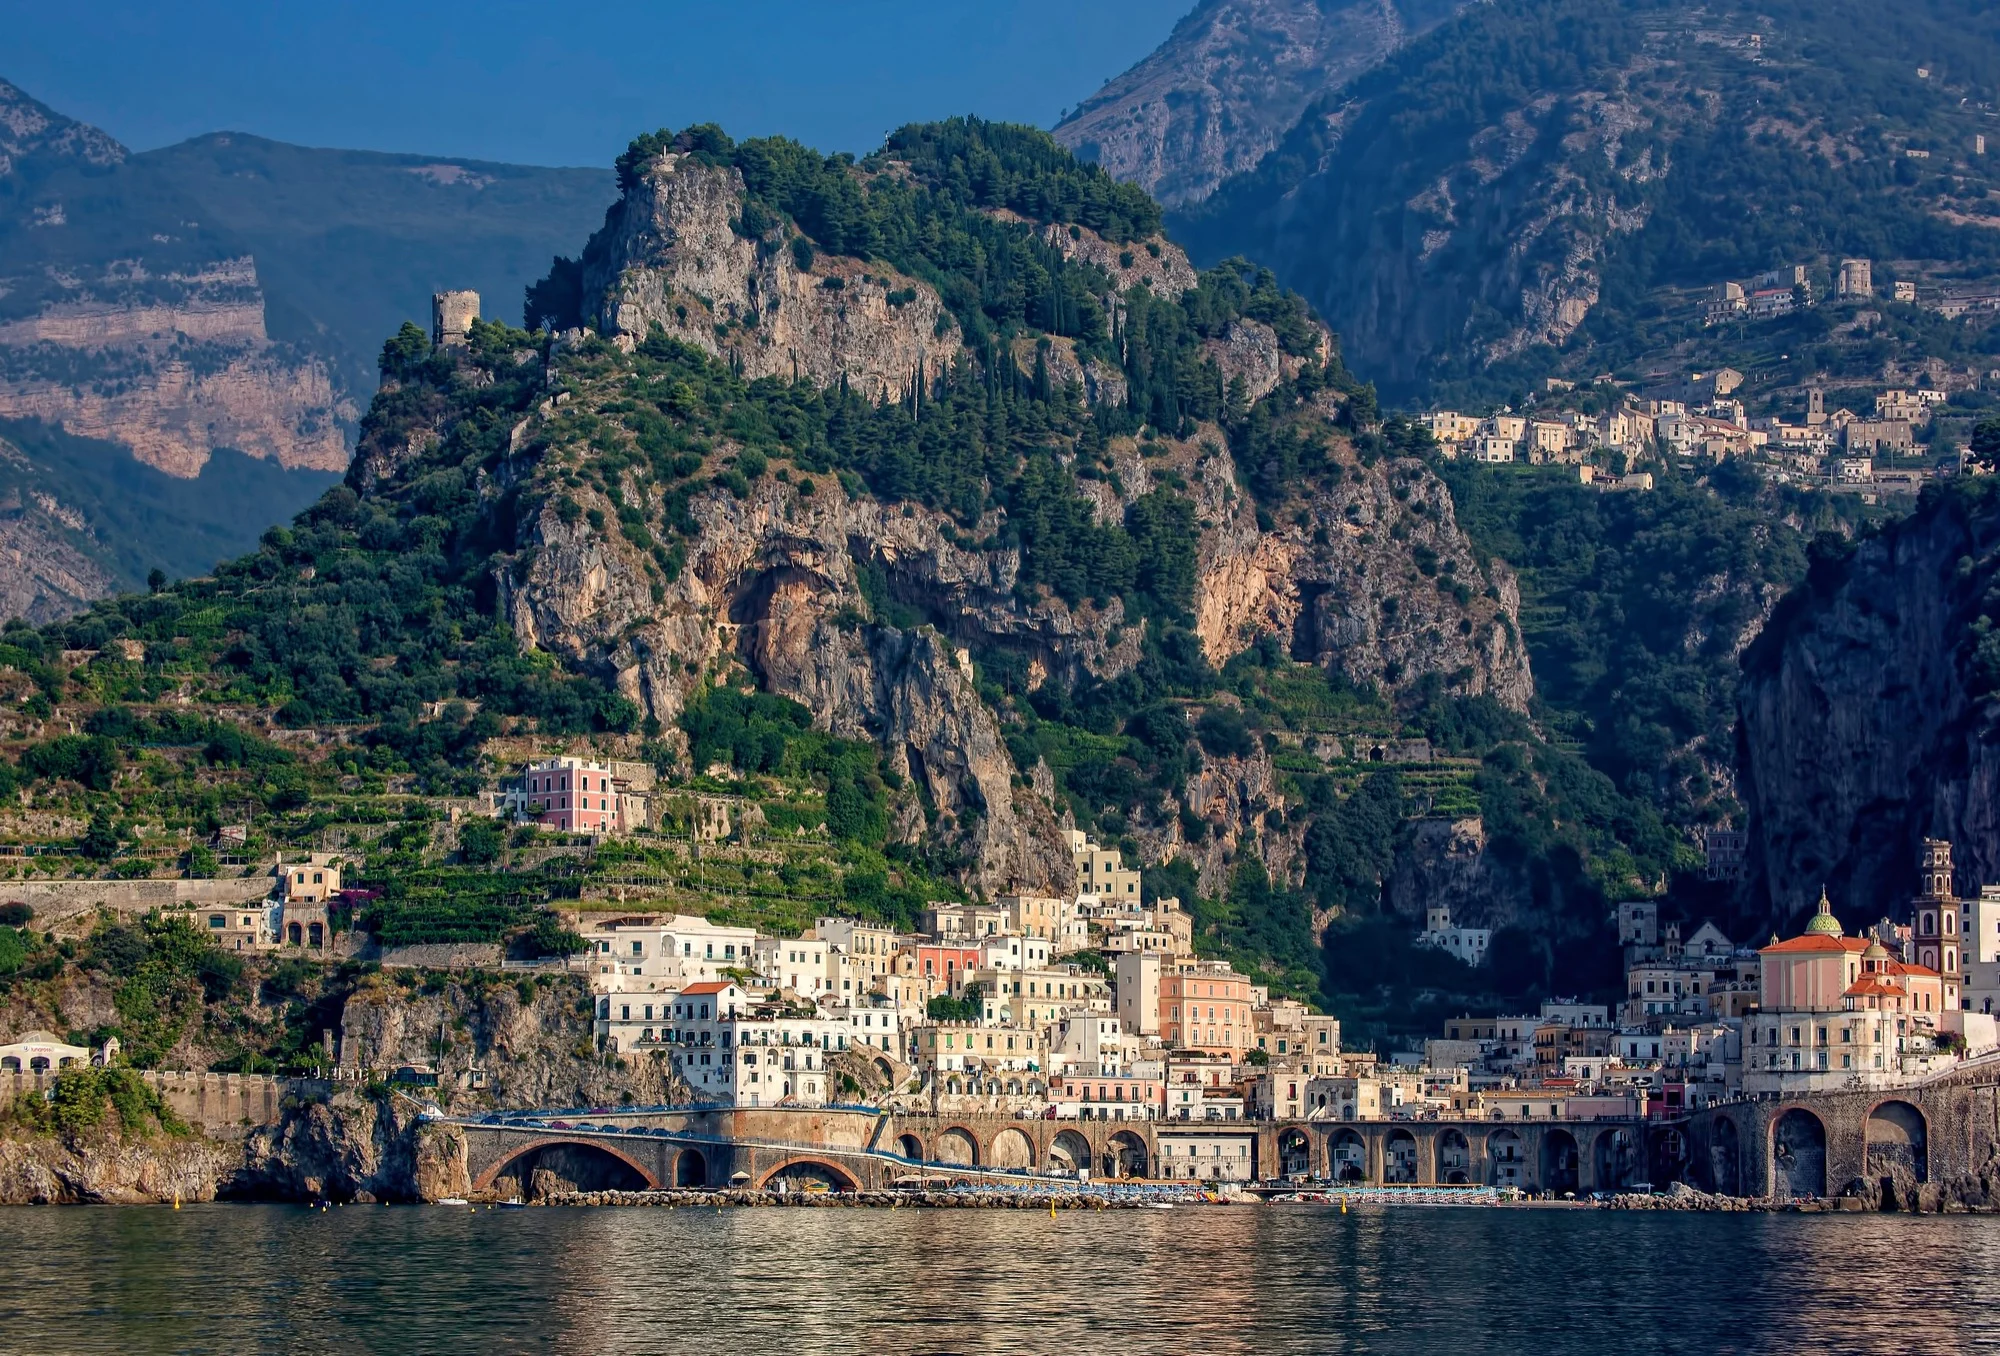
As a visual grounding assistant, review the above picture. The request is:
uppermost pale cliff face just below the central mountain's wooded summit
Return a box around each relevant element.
[584,152,960,396]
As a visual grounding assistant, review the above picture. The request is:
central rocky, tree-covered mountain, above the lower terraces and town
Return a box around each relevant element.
[39,122,1560,992]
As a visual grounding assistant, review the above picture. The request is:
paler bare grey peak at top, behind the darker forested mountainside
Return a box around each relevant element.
[1056,0,1456,206]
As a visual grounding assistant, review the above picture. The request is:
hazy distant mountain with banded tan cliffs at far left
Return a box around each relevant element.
[0,82,608,620]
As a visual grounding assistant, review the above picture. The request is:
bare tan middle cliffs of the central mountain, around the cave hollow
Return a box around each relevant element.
[500,380,1534,890]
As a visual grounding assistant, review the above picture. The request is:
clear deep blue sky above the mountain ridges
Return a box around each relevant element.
[0,0,1194,164]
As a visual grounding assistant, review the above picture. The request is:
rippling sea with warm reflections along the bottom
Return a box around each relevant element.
[0,1206,2000,1356]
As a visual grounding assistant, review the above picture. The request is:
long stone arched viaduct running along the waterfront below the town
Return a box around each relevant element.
[452,1070,2000,1204]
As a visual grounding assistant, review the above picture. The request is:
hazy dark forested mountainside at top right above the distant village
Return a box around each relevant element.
[1176,0,2000,396]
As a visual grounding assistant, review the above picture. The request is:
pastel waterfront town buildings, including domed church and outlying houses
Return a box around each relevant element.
[172,792,2000,1182]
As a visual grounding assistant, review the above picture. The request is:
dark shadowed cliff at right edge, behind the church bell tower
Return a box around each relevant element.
[1738,482,2000,930]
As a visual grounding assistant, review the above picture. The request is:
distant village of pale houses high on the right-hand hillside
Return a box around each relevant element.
[1418,252,2000,504]
